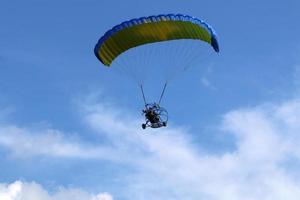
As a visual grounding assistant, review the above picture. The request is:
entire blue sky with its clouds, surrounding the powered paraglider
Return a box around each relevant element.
[0,0,300,200]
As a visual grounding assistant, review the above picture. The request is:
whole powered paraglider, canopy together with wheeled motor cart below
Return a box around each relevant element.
[94,14,219,129]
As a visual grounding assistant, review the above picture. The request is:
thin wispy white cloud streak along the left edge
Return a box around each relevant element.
[0,125,118,159]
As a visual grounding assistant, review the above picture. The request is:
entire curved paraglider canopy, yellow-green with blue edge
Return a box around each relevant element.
[94,14,219,66]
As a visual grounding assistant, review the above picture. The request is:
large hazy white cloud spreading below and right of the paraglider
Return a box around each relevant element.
[77,96,300,200]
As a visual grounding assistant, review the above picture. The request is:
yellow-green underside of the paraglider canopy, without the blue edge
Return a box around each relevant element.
[95,21,213,66]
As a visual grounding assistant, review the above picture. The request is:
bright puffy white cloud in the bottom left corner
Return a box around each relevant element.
[0,181,113,200]
